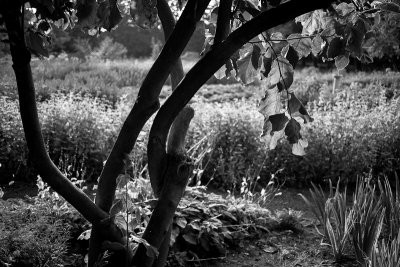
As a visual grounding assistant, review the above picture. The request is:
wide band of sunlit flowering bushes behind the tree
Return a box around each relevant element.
[0,59,400,188]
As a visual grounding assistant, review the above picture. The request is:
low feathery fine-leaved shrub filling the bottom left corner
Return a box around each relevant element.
[0,200,80,267]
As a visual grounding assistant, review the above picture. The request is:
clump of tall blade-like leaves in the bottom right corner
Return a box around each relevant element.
[302,177,400,267]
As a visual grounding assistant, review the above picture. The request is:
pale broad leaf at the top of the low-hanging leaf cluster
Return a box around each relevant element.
[268,55,294,90]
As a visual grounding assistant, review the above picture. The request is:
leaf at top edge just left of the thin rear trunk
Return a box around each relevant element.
[130,0,158,29]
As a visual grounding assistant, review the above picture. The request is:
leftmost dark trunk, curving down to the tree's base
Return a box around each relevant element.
[2,7,132,264]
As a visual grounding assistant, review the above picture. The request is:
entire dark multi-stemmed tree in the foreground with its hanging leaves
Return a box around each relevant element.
[0,0,400,266]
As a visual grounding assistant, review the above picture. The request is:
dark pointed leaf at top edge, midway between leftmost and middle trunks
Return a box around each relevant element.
[97,0,122,31]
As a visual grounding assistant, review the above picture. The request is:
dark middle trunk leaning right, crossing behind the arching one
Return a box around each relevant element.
[89,0,210,266]
